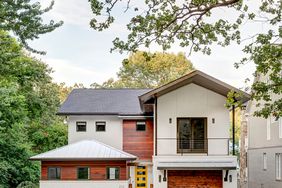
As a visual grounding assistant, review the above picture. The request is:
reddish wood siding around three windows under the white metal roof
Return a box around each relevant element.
[41,161,128,180]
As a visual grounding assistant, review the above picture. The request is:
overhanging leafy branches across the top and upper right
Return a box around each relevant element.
[90,0,282,117]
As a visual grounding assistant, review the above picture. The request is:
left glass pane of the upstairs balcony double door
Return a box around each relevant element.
[178,119,192,149]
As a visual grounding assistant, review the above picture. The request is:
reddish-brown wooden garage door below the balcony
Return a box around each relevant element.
[168,170,222,188]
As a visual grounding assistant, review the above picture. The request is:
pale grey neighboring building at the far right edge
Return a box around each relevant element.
[245,73,282,188]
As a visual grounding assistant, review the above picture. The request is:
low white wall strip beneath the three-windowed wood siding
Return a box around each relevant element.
[40,180,128,188]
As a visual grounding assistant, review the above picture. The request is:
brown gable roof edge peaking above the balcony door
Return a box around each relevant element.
[139,70,250,104]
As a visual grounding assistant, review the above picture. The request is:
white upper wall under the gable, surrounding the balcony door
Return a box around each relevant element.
[157,84,230,155]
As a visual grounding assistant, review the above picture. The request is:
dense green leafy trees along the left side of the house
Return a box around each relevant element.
[0,30,67,188]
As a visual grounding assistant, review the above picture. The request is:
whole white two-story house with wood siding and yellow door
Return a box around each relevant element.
[31,71,249,188]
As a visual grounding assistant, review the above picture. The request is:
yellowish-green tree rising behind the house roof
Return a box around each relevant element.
[91,51,194,88]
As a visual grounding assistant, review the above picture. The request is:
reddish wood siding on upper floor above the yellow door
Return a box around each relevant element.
[123,119,154,160]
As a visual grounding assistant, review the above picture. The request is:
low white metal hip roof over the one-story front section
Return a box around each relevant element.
[30,140,137,161]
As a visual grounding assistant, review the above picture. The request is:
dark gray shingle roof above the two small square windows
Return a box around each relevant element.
[58,89,151,115]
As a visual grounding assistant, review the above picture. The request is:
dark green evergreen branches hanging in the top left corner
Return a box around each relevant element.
[0,0,63,53]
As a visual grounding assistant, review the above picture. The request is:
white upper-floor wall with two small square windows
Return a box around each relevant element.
[68,115,122,149]
